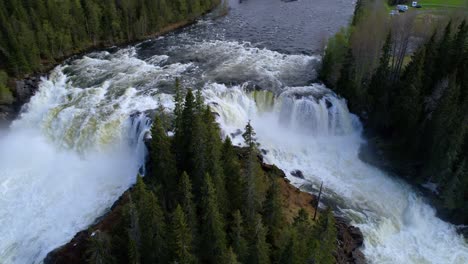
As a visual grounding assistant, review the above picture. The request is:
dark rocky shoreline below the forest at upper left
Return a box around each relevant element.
[0,1,224,128]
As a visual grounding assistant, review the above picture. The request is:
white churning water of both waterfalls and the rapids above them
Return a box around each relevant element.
[0,0,468,264]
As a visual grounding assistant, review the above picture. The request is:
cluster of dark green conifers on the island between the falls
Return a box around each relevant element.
[87,82,337,264]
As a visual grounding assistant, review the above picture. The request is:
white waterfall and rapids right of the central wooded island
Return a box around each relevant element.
[205,85,468,264]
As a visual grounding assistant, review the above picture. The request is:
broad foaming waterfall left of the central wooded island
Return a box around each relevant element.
[0,49,179,264]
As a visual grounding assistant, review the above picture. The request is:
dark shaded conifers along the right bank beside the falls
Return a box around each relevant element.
[322,0,468,223]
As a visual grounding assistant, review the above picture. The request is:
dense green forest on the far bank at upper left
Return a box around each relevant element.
[0,0,219,75]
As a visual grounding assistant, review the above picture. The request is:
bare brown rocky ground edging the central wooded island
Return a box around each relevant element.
[44,147,366,264]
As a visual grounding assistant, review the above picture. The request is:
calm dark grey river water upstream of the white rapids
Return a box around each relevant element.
[142,0,355,55]
